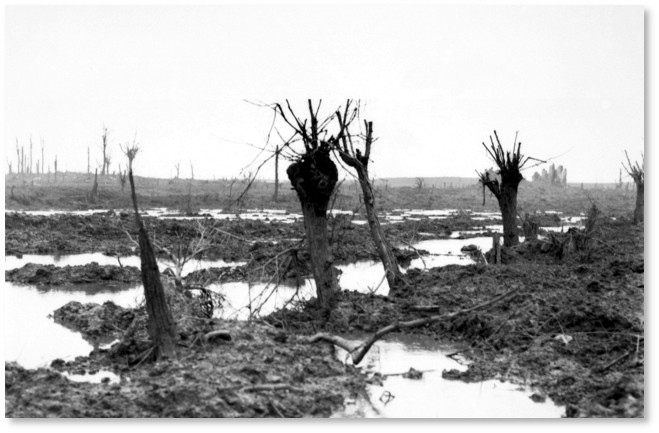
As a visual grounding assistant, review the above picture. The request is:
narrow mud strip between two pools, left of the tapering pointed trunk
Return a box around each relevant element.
[5,262,141,286]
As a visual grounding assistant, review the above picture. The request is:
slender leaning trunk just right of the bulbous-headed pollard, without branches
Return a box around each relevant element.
[357,166,403,294]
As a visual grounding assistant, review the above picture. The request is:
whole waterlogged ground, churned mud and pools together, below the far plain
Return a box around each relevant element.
[4,208,644,417]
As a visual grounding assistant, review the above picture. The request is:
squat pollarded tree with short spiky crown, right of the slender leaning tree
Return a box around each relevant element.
[478,131,535,247]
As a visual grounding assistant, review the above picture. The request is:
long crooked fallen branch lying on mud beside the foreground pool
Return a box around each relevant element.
[305,288,519,365]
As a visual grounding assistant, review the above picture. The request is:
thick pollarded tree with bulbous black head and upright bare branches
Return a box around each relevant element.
[275,100,343,313]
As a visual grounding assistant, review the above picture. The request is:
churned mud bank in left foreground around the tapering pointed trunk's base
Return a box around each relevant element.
[5,285,365,418]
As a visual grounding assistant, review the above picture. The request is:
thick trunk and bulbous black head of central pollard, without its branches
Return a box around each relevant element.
[286,147,339,313]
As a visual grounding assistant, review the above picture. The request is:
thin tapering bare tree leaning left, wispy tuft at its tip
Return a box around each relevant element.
[122,141,176,359]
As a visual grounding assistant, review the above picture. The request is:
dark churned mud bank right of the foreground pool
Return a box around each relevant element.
[266,220,645,417]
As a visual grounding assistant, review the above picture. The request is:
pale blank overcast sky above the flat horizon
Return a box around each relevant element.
[4,5,644,182]
